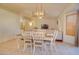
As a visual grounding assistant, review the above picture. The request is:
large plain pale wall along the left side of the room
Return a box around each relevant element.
[0,9,19,42]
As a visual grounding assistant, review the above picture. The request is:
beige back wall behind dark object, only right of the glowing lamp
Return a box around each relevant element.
[32,18,57,29]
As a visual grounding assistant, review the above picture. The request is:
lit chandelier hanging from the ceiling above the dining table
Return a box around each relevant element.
[33,4,44,19]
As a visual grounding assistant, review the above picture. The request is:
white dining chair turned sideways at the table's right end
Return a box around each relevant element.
[44,30,58,53]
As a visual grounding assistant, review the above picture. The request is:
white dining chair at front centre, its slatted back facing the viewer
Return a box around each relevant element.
[33,32,44,54]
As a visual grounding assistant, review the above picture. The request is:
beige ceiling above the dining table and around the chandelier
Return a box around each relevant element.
[0,3,71,17]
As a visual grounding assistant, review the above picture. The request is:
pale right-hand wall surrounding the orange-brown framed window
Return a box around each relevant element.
[58,4,78,45]
